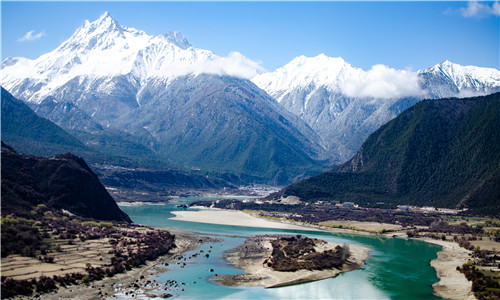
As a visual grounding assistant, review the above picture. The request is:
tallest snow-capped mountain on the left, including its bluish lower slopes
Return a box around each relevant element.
[0,13,324,184]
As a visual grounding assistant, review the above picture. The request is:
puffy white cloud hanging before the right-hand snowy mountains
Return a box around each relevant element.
[342,65,425,99]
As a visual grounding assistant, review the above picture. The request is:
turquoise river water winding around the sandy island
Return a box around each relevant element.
[120,197,441,299]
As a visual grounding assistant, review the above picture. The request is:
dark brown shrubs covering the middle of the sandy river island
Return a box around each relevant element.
[264,236,349,272]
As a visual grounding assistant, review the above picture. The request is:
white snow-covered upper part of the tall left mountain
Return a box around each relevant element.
[0,12,262,103]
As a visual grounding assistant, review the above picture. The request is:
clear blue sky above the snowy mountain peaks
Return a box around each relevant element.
[1,1,500,71]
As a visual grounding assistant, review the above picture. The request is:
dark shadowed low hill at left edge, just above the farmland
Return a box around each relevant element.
[2,143,132,222]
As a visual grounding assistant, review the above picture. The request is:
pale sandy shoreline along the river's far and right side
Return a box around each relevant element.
[173,208,475,299]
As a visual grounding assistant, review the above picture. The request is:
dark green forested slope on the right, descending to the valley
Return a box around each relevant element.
[272,93,500,216]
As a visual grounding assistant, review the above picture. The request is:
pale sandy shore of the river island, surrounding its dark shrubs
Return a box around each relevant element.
[212,235,371,288]
